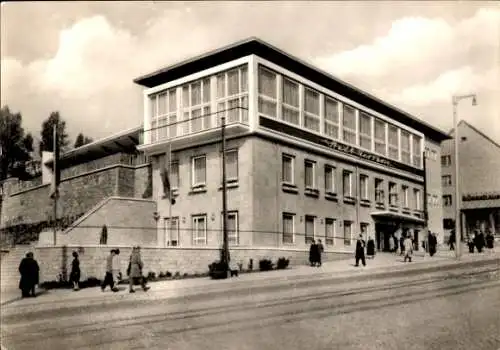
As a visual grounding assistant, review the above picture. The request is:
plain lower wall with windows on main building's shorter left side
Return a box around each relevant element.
[153,138,253,247]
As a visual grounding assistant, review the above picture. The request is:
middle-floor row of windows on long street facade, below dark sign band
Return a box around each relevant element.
[281,154,421,210]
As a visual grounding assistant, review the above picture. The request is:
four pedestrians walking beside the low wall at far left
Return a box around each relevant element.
[19,246,149,298]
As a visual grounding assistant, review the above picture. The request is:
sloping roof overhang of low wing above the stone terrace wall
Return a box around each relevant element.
[45,126,142,168]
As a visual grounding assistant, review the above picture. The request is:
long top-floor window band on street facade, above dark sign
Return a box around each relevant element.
[258,66,422,167]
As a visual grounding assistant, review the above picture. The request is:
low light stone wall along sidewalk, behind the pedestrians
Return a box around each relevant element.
[34,246,351,283]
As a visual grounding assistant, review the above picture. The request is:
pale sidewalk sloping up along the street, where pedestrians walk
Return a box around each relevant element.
[1,248,500,309]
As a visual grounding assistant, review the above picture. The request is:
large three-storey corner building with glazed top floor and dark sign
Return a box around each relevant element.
[135,38,449,256]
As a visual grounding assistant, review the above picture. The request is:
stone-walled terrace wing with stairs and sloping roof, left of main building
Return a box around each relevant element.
[0,127,156,245]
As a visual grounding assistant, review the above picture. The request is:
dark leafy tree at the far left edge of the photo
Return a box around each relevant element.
[0,106,33,181]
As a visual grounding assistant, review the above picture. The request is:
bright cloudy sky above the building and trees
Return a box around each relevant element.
[1,1,500,146]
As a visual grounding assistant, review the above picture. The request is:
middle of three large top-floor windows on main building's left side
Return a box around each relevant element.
[182,78,211,134]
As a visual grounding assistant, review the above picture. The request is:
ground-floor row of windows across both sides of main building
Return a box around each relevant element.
[164,211,369,247]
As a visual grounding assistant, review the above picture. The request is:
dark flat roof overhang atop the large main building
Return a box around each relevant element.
[134,37,451,142]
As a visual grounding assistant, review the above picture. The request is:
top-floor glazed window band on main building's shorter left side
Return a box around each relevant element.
[149,66,248,142]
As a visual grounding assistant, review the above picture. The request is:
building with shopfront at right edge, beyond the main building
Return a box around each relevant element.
[441,120,500,241]
